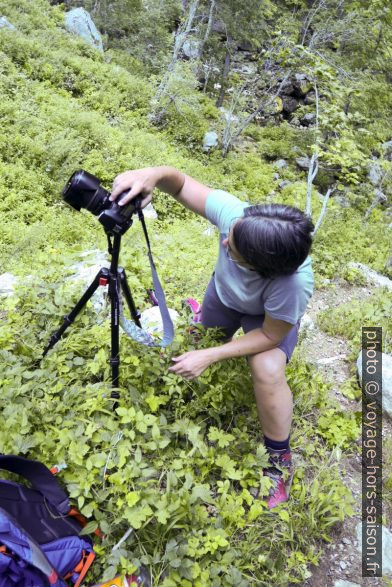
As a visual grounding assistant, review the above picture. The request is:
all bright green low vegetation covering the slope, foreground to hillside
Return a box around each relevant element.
[0,0,391,587]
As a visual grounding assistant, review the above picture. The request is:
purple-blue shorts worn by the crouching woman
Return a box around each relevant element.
[201,277,300,364]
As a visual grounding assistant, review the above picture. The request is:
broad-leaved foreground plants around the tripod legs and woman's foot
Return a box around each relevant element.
[0,276,351,585]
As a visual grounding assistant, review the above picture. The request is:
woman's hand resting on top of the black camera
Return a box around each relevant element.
[110,167,160,208]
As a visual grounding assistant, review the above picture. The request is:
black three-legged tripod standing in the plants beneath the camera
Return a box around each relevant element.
[42,233,140,399]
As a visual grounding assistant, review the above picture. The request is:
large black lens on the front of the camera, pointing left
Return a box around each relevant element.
[62,169,110,216]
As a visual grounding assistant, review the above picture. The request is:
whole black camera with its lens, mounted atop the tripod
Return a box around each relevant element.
[62,169,142,234]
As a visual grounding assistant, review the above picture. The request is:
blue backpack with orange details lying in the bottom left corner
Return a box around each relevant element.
[0,455,95,587]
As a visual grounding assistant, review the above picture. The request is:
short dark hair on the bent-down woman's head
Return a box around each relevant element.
[233,204,314,278]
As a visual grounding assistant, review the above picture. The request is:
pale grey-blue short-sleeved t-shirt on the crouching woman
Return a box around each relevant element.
[206,190,314,324]
